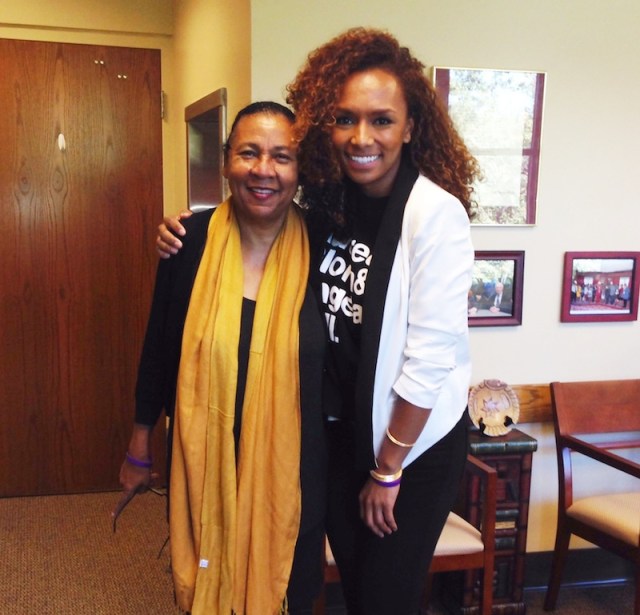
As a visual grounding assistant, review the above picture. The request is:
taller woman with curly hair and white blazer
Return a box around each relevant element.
[287,28,477,615]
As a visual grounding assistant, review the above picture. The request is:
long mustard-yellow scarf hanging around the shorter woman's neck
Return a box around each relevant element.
[169,200,309,615]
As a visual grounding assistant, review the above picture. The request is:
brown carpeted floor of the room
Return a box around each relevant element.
[0,492,634,615]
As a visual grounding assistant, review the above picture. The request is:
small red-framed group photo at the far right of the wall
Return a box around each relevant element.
[560,252,640,322]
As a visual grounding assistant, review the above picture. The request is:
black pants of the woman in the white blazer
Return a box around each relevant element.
[327,418,467,615]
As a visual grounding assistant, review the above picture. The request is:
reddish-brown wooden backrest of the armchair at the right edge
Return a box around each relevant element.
[551,380,640,436]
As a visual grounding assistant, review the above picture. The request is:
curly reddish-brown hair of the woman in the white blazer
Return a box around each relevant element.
[287,28,480,227]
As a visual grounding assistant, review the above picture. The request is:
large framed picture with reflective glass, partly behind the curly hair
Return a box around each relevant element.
[433,67,546,226]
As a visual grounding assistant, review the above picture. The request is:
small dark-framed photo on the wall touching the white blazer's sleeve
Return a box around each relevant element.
[467,251,524,327]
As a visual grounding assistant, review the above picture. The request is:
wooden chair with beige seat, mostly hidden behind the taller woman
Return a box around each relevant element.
[314,455,497,615]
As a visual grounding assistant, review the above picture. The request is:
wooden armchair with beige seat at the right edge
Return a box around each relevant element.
[544,380,640,615]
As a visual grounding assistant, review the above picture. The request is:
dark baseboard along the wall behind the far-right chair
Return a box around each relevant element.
[524,549,634,590]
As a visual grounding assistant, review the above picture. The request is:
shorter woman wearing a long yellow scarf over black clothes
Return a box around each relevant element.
[121,102,325,615]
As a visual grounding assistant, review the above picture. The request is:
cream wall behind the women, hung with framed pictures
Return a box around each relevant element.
[252,0,640,551]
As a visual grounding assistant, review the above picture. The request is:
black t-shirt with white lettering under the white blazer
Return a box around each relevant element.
[319,195,388,420]
